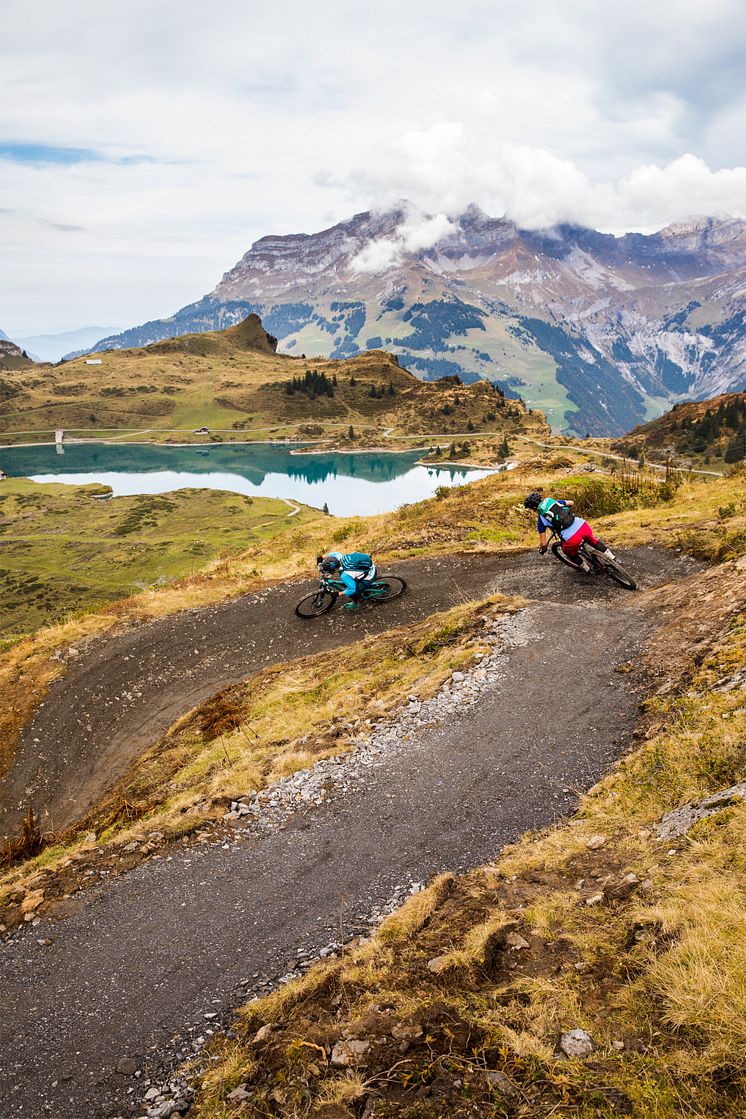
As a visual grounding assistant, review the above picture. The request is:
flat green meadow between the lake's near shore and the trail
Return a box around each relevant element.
[0,479,321,639]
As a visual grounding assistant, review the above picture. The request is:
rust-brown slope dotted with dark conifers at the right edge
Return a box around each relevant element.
[613,393,746,470]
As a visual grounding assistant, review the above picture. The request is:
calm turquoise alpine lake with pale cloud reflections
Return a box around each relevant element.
[0,443,491,516]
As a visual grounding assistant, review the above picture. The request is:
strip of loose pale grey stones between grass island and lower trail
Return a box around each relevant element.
[224,608,539,835]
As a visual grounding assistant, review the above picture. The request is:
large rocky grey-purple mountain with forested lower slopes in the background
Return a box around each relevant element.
[72,206,746,435]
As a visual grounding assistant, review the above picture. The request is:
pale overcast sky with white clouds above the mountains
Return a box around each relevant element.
[0,0,746,337]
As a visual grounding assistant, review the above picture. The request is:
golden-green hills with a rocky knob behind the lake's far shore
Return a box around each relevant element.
[0,316,548,445]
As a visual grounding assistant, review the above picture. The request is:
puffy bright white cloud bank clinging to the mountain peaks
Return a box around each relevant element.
[339,123,746,272]
